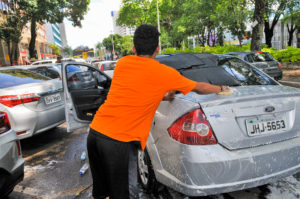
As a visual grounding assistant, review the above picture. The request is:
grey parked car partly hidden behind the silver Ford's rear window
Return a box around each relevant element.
[226,51,282,80]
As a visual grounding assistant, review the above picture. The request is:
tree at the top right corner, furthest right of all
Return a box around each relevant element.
[282,1,300,46]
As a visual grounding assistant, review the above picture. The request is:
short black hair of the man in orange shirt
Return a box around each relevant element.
[133,24,160,55]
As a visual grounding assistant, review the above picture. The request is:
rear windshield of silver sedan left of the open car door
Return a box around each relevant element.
[0,69,50,89]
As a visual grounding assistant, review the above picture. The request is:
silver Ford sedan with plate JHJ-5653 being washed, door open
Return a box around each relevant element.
[63,53,300,196]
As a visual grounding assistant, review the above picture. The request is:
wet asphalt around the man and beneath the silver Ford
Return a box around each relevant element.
[8,124,300,199]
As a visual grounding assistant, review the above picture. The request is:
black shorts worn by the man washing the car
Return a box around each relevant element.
[87,129,138,199]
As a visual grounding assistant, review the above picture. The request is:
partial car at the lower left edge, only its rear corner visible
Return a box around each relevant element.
[0,111,24,198]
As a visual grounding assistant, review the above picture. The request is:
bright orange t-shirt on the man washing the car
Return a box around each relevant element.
[90,55,196,149]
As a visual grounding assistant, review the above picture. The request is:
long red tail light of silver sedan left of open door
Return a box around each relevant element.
[0,93,40,107]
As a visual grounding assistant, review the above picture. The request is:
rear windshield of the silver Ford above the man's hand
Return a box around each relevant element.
[179,58,277,86]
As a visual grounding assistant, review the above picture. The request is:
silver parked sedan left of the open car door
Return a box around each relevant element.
[0,67,65,139]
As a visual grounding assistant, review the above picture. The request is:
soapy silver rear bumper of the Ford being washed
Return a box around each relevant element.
[151,135,300,196]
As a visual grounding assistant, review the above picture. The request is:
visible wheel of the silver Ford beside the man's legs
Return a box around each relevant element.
[138,149,157,193]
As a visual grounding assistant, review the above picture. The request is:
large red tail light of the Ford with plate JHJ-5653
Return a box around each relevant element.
[168,109,217,145]
